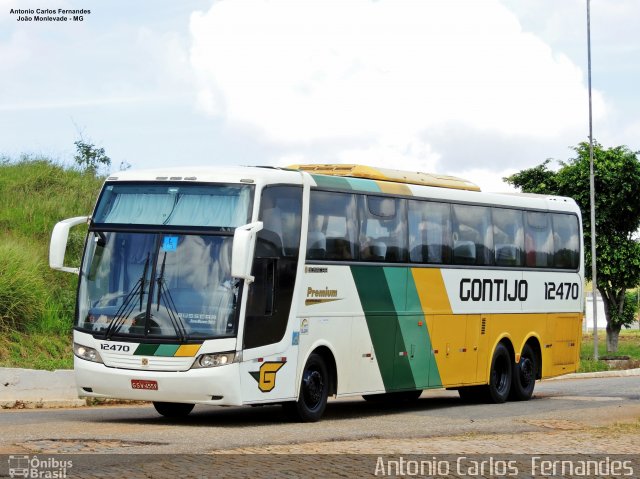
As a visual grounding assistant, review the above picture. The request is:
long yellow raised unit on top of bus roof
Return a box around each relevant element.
[287,164,480,191]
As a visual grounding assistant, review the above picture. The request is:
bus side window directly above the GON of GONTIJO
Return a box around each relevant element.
[452,205,494,266]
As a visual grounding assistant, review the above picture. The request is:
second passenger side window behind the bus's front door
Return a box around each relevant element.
[360,196,407,263]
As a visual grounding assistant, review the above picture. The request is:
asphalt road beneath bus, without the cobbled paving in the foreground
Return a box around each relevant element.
[0,376,640,454]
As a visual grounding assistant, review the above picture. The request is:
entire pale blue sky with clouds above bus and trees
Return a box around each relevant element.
[0,0,640,191]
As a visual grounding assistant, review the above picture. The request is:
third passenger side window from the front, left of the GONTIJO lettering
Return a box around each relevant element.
[408,200,451,264]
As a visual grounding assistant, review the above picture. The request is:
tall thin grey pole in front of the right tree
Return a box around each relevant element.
[587,0,598,361]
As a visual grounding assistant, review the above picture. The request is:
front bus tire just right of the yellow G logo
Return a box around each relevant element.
[283,353,329,422]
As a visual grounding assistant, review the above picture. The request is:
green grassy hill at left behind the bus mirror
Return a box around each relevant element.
[0,157,103,369]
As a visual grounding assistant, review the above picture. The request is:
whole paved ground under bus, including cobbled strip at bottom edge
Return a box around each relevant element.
[0,376,640,479]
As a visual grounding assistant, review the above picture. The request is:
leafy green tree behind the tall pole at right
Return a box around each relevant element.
[504,142,640,353]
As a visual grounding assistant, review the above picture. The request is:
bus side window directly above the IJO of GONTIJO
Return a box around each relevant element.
[492,208,524,266]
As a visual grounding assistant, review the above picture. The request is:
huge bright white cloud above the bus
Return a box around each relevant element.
[191,0,605,156]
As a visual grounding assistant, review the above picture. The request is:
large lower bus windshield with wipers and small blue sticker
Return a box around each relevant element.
[76,231,238,341]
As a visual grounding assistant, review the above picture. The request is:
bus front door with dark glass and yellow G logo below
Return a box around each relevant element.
[241,186,302,402]
